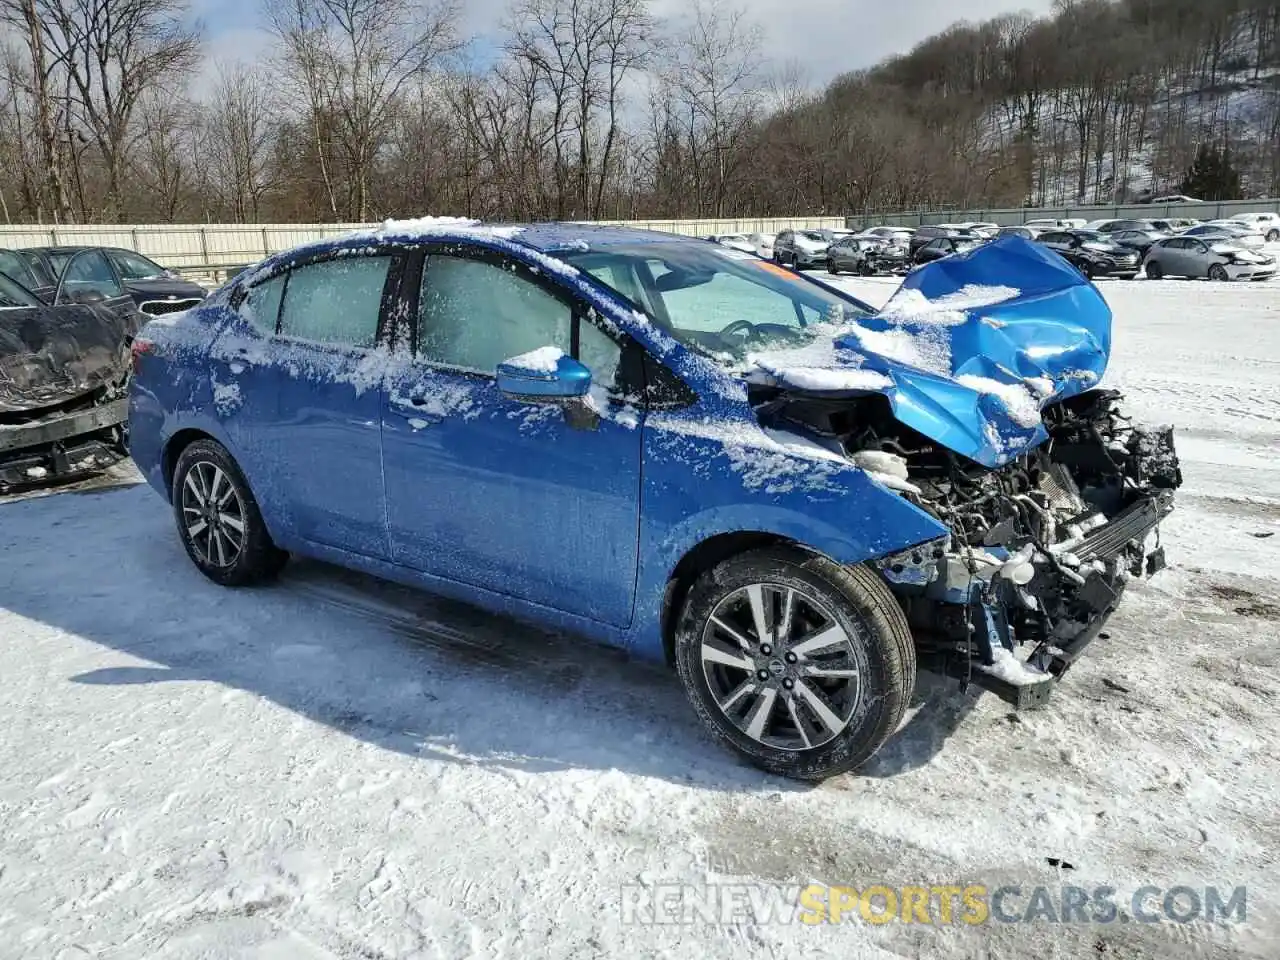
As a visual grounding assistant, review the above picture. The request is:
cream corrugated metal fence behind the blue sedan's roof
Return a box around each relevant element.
[0,216,845,273]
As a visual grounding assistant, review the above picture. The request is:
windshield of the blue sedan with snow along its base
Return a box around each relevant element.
[556,242,873,364]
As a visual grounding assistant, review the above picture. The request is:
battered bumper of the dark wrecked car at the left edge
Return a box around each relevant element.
[0,398,129,489]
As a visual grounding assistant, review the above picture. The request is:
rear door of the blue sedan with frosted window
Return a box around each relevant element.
[227,248,407,558]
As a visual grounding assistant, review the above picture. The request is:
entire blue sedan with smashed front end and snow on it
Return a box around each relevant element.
[129,220,1180,780]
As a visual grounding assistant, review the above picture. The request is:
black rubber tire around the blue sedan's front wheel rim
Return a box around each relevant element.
[675,547,915,780]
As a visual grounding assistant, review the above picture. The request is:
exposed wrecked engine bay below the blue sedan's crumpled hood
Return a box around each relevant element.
[758,389,1181,705]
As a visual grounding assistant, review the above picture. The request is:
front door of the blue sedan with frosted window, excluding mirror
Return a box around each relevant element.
[383,246,643,626]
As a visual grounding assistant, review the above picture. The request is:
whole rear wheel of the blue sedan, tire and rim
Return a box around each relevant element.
[172,440,288,586]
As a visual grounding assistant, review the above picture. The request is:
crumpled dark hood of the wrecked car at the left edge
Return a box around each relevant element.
[0,305,141,412]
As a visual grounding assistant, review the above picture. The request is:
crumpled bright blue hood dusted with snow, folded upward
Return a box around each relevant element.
[750,237,1111,467]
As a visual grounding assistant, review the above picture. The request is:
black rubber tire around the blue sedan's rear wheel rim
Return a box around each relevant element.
[170,440,289,586]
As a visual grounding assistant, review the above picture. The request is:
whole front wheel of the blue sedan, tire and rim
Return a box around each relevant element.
[676,548,915,780]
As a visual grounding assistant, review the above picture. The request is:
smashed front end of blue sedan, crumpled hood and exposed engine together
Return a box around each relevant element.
[754,242,1181,707]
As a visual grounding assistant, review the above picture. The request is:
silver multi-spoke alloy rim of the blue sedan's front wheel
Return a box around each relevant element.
[700,584,863,750]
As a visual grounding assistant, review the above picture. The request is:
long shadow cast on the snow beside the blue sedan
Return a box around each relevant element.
[0,486,973,792]
